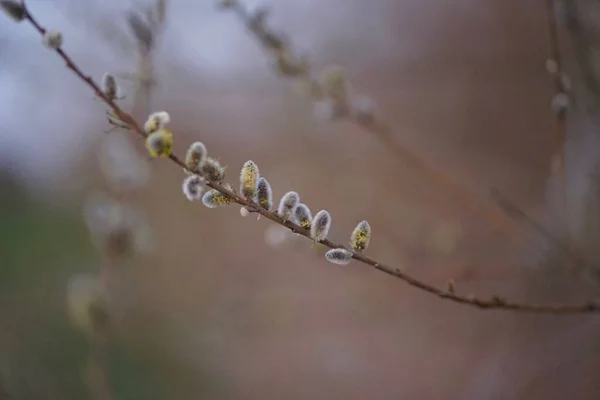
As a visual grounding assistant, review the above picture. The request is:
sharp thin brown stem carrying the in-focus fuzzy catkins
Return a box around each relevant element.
[17,4,600,315]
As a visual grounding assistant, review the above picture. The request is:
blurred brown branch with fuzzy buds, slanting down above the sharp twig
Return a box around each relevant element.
[219,0,544,248]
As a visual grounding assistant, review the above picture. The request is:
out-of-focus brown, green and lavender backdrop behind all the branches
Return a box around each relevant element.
[0,0,600,399]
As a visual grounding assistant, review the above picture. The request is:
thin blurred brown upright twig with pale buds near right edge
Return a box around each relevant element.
[545,0,567,229]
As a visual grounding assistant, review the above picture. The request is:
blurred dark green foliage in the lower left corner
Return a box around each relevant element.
[0,180,164,400]
